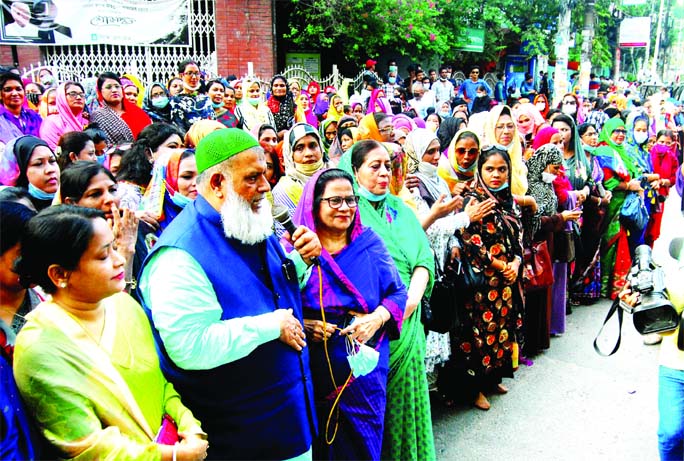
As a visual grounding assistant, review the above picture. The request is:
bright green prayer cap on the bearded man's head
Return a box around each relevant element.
[195,128,259,174]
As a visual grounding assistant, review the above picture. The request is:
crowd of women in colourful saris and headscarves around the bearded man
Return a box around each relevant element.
[0,61,684,461]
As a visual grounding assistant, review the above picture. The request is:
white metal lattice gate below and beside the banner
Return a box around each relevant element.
[36,0,218,85]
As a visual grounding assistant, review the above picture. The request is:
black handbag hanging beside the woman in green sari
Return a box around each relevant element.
[420,253,460,333]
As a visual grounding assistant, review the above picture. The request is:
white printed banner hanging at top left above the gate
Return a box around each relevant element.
[0,0,190,46]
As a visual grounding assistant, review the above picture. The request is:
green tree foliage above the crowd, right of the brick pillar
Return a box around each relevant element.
[284,0,656,67]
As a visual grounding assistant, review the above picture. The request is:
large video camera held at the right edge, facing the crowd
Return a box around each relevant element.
[620,245,679,335]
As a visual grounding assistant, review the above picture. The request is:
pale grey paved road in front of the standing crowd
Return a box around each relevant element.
[432,301,658,461]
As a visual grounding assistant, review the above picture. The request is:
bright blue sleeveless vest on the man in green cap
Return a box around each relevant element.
[143,196,315,459]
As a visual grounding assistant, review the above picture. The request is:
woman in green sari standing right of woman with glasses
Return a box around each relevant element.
[339,140,435,460]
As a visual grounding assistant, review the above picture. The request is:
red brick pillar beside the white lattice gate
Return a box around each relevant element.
[215,0,276,77]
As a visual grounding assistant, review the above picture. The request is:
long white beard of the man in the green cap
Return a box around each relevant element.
[221,186,273,245]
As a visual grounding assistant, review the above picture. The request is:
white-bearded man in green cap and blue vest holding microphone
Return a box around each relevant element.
[140,128,321,459]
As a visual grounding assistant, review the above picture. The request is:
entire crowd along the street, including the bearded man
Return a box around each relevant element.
[0,54,684,461]
